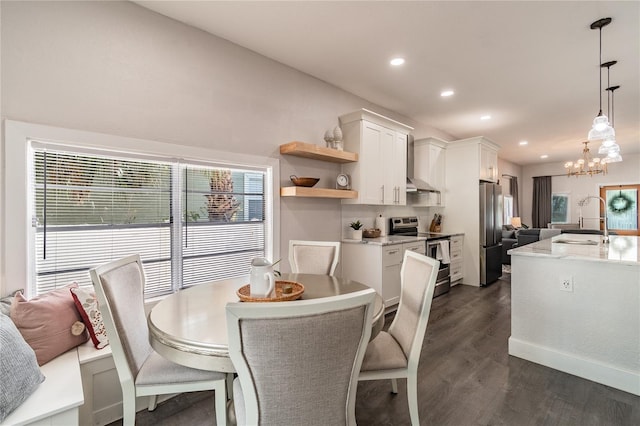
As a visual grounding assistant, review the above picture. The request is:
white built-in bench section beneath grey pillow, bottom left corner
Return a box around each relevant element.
[0,349,84,426]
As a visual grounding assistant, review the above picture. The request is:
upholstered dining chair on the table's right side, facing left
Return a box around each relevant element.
[358,250,440,426]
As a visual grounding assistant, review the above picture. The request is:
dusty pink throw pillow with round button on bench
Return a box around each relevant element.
[11,283,89,365]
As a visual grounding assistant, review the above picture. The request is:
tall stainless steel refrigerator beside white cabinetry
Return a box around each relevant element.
[480,182,502,286]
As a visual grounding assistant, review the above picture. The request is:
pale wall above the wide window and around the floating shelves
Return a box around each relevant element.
[0,2,451,294]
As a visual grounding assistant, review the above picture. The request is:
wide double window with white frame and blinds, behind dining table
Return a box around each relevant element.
[3,120,279,298]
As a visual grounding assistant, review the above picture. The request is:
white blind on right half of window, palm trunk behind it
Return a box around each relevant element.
[181,166,265,287]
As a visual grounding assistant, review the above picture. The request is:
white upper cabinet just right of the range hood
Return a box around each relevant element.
[411,138,447,207]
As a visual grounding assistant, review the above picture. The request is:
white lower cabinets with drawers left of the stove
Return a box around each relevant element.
[342,241,425,311]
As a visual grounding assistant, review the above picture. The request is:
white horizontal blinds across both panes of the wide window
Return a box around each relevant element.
[31,148,266,297]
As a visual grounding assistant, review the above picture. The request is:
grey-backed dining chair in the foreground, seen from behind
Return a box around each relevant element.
[226,289,375,426]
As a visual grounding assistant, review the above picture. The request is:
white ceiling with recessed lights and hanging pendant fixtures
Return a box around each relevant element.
[136,1,640,165]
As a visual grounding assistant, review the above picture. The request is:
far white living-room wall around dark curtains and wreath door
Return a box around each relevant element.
[521,150,640,229]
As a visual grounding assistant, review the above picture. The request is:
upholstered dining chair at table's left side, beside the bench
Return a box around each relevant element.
[89,254,227,426]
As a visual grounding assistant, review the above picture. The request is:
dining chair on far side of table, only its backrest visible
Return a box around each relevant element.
[289,240,340,275]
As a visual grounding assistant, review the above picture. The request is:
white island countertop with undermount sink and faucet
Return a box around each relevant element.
[508,234,640,265]
